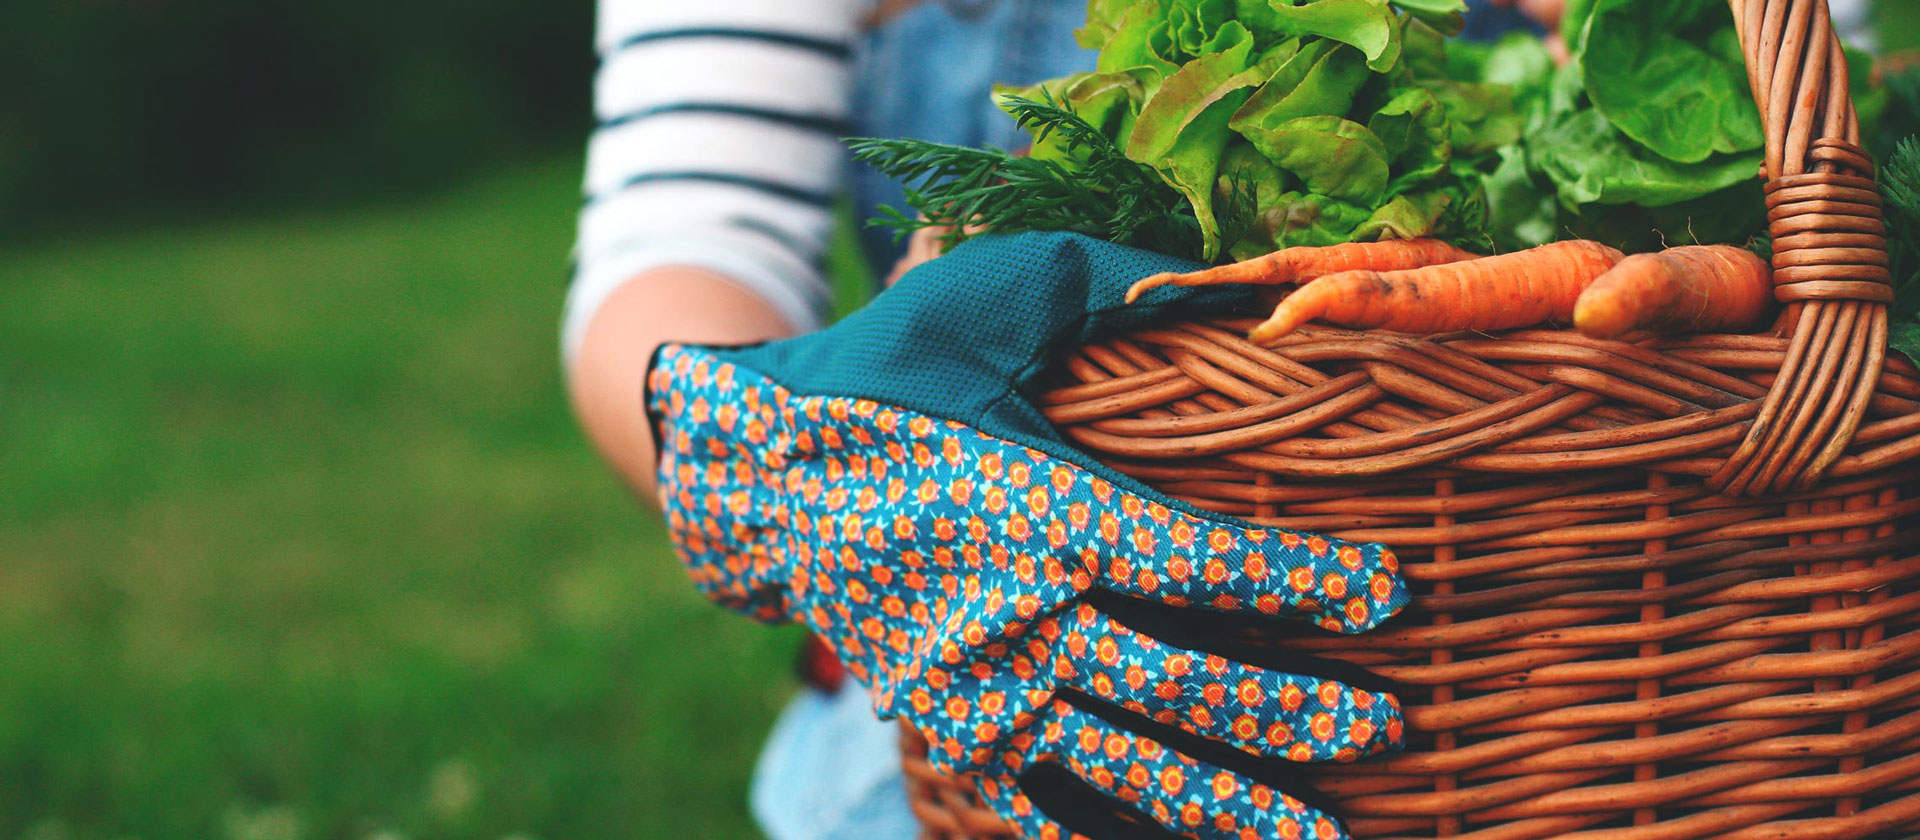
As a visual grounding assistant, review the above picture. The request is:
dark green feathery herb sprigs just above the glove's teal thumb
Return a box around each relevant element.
[849,96,1202,259]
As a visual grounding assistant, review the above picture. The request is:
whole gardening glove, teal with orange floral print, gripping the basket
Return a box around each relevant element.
[647,234,1407,838]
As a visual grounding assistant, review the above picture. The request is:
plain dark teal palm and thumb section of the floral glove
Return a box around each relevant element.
[714,232,1254,479]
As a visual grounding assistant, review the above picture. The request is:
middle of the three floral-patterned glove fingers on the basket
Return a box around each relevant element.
[1056,604,1405,761]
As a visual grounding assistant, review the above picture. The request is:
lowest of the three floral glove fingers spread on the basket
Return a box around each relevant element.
[1021,702,1346,840]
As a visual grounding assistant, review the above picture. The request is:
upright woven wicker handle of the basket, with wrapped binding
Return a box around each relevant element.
[1709,0,1893,495]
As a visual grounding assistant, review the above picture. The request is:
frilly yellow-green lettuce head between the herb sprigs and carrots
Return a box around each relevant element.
[998,0,1519,259]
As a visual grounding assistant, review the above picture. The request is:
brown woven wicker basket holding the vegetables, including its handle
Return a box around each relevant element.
[902,0,1920,840]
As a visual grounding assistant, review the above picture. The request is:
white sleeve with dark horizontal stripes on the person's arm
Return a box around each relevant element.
[563,0,858,359]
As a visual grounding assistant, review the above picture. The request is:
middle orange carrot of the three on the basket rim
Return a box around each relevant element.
[1252,240,1622,343]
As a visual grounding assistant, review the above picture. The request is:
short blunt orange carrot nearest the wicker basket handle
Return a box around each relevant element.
[1572,245,1774,338]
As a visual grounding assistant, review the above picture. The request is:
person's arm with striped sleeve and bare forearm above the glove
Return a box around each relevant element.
[561,0,864,501]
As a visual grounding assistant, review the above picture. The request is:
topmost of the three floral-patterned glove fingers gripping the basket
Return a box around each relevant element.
[1071,489,1411,633]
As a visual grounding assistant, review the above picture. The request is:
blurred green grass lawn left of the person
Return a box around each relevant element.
[0,155,817,840]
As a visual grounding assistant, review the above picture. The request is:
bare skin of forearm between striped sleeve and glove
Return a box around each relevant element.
[568,268,793,502]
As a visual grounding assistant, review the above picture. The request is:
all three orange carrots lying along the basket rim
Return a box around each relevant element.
[1127,240,1772,343]
